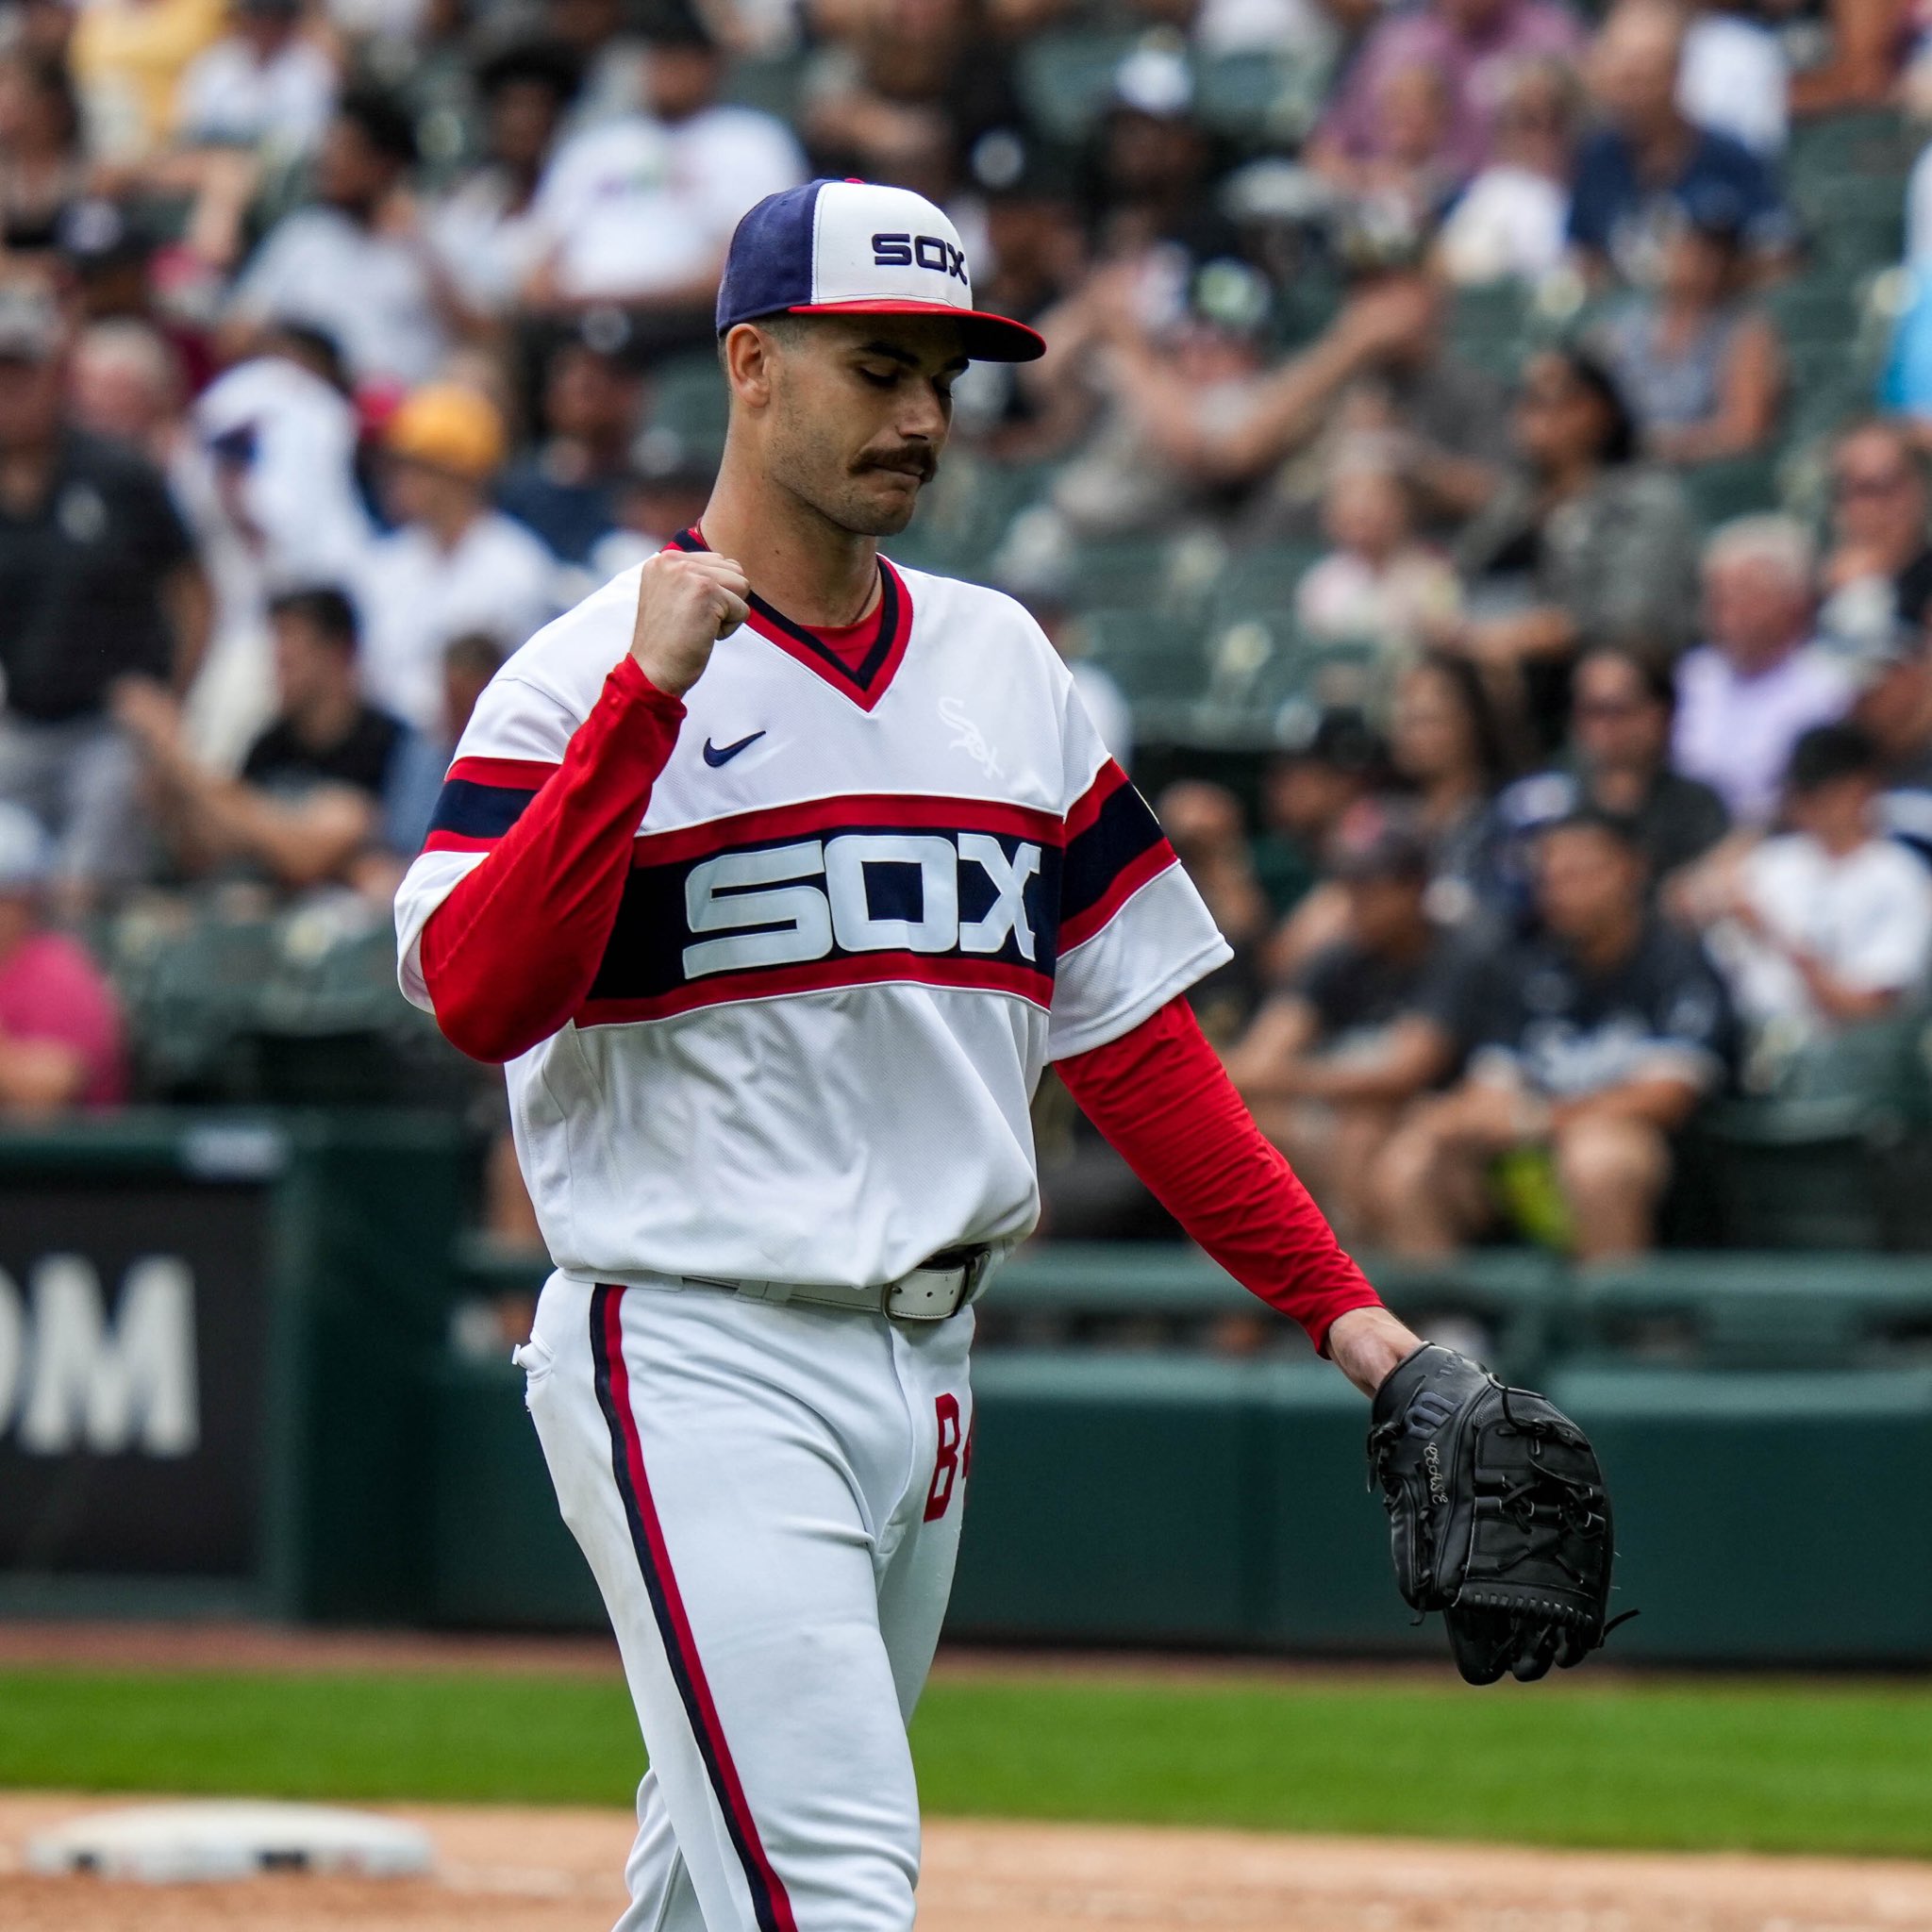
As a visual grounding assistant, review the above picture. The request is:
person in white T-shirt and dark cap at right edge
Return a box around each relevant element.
[1709,724,1932,1058]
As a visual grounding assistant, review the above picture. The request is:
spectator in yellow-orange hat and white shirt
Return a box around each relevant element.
[359,383,557,730]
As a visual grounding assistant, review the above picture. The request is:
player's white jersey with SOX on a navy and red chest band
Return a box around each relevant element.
[396,544,1229,1285]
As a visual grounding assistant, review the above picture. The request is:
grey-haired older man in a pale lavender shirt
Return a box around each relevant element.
[1672,516,1853,824]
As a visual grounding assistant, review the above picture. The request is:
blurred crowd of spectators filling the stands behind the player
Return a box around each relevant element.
[0,0,1932,1257]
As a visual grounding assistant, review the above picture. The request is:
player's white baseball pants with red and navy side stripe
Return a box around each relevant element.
[520,1275,974,1932]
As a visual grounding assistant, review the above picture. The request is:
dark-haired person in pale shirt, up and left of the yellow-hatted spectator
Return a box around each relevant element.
[225,89,448,392]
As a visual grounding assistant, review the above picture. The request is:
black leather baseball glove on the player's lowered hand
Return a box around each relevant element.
[1368,1342,1635,1685]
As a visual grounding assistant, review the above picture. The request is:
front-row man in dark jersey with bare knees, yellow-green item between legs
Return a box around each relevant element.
[1372,808,1737,1261]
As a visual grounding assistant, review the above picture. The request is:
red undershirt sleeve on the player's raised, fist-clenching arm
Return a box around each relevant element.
[421,657,684,1060]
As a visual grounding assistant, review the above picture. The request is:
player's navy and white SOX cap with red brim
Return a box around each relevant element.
[717,179,1047,361]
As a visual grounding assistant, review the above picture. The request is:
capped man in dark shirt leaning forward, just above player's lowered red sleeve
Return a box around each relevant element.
[1224,806,1482,1241]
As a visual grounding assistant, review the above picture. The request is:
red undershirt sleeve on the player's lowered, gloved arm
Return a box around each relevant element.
[1057,999,1381,1353]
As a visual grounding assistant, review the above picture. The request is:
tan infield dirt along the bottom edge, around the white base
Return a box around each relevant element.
[0,1797,1932,1932]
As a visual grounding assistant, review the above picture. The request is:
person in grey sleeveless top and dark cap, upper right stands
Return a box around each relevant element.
[1596,192,1785,464]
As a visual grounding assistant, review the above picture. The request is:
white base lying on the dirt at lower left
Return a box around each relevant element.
[27,1799,433,1884]
